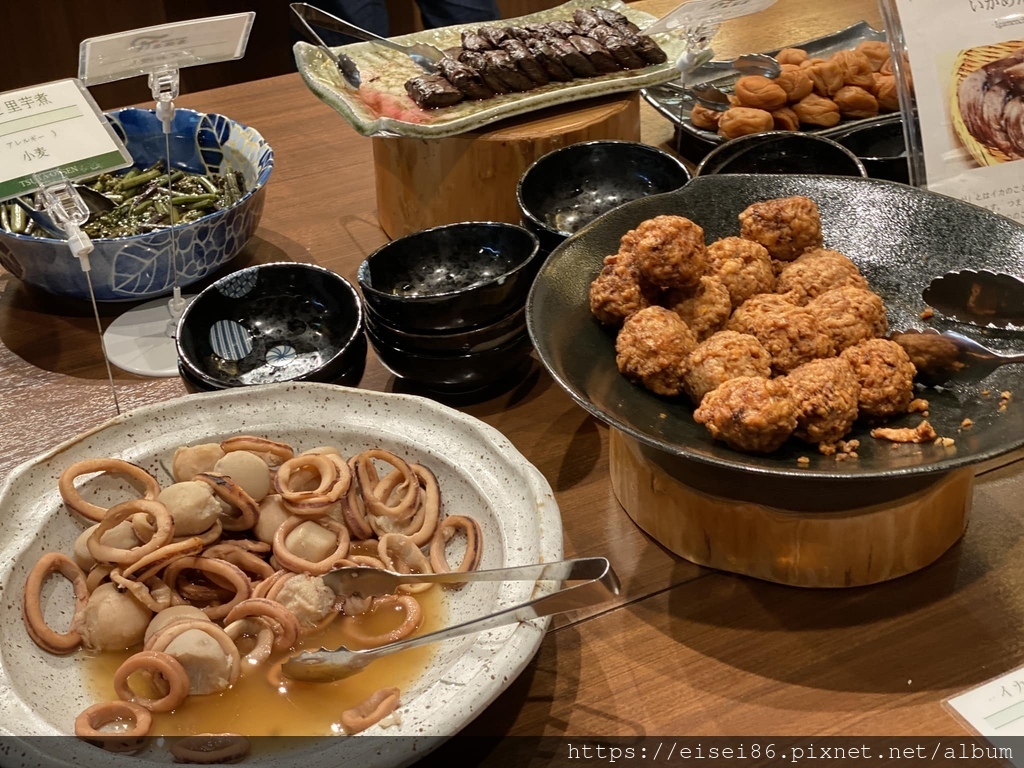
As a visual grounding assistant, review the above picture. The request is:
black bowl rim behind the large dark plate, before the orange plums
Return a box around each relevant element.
[694,131,867,176]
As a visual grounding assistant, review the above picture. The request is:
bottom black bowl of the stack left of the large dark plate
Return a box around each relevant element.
[367,326,534,394]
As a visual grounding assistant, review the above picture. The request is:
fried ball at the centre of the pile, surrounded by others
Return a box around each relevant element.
[726,294,836,376]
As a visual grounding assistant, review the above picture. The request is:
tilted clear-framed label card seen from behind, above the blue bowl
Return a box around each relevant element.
[78,11,256,85]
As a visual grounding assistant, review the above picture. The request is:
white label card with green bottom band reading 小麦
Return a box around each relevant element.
[0,80,132,201]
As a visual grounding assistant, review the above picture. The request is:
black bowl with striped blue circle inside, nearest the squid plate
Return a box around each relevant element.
[176,262,367,389]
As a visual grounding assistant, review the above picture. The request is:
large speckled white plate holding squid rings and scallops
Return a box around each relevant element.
[0,384,562,768]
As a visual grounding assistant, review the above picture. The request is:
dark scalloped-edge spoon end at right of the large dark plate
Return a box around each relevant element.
[924,269,1024,331]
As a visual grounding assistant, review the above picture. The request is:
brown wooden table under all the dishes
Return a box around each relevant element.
[0,0,1024,749]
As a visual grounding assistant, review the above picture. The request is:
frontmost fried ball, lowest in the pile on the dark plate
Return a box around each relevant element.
[693,376,798,454]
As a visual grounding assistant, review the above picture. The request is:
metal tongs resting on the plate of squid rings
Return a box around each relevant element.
[281,557,620,683]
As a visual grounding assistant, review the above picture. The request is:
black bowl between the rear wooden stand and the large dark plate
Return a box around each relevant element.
[516,141,690,251]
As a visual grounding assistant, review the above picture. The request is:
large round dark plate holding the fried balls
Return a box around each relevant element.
[526,175,1024,509]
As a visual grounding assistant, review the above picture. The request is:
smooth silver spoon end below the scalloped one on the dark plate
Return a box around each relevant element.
[890,329,1024,385]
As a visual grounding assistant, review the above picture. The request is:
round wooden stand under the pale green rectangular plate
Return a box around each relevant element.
[373,92,640,239]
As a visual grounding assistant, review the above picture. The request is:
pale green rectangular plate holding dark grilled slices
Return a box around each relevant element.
[295,0,685,138]
